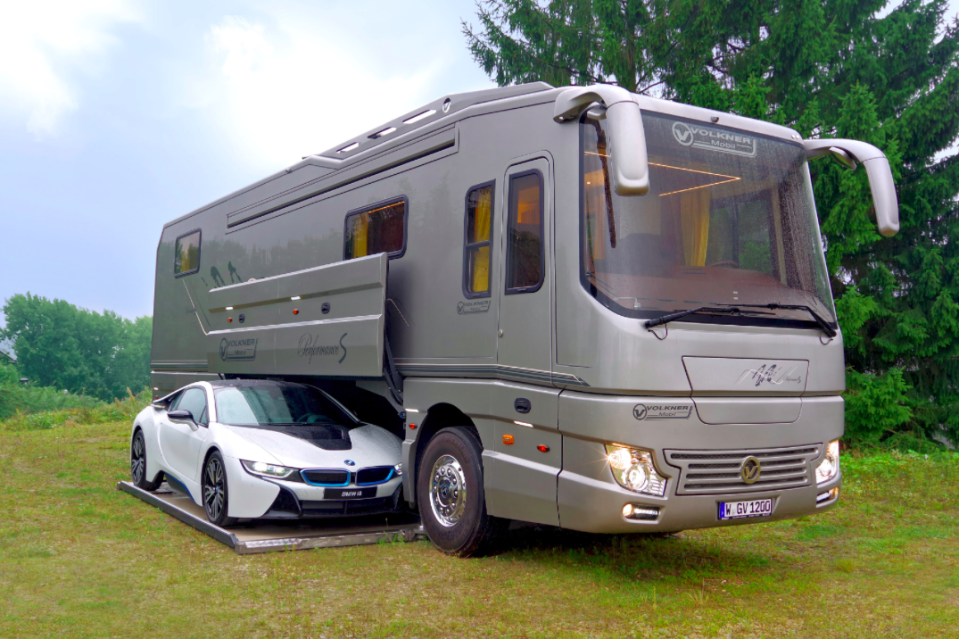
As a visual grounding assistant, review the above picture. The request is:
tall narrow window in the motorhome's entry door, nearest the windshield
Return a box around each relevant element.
[506,171,544,295]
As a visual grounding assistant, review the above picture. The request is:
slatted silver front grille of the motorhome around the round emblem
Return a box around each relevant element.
[665,444,820,495]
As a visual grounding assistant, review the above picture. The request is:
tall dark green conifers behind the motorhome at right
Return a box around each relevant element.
[463,0,959,441]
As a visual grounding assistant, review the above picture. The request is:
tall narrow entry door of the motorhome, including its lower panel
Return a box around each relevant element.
[486,158,562,526]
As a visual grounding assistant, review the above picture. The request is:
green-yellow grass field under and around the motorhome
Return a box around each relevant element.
[0,422,959,639]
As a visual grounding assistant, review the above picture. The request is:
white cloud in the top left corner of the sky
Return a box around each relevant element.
[0,0,138,138]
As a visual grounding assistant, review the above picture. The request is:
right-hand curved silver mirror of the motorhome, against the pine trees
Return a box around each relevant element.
[803,140,899,237]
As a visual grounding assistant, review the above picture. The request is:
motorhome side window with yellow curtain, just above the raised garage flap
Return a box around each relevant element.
[343,197,407,260]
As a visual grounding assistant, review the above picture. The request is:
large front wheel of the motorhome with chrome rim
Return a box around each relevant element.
[416,428,509,557]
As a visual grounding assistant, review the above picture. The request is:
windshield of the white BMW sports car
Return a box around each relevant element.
[213,384,357,426]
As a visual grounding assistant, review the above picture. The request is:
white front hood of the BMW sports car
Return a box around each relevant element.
[227,424,402,470]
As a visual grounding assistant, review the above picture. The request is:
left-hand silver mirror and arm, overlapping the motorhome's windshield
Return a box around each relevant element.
[553,84,649,196]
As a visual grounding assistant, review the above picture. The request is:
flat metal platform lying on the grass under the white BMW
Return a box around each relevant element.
[117,481,426,555]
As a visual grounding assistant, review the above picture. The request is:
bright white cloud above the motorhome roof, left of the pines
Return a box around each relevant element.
[206,15,450,170]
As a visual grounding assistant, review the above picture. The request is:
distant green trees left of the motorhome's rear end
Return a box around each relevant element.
[0,293,153,401]
